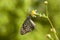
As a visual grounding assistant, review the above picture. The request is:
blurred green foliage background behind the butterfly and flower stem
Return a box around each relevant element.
[0,0,60,40]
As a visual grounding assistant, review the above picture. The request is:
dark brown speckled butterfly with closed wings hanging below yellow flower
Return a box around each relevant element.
[21,16,35,35]
